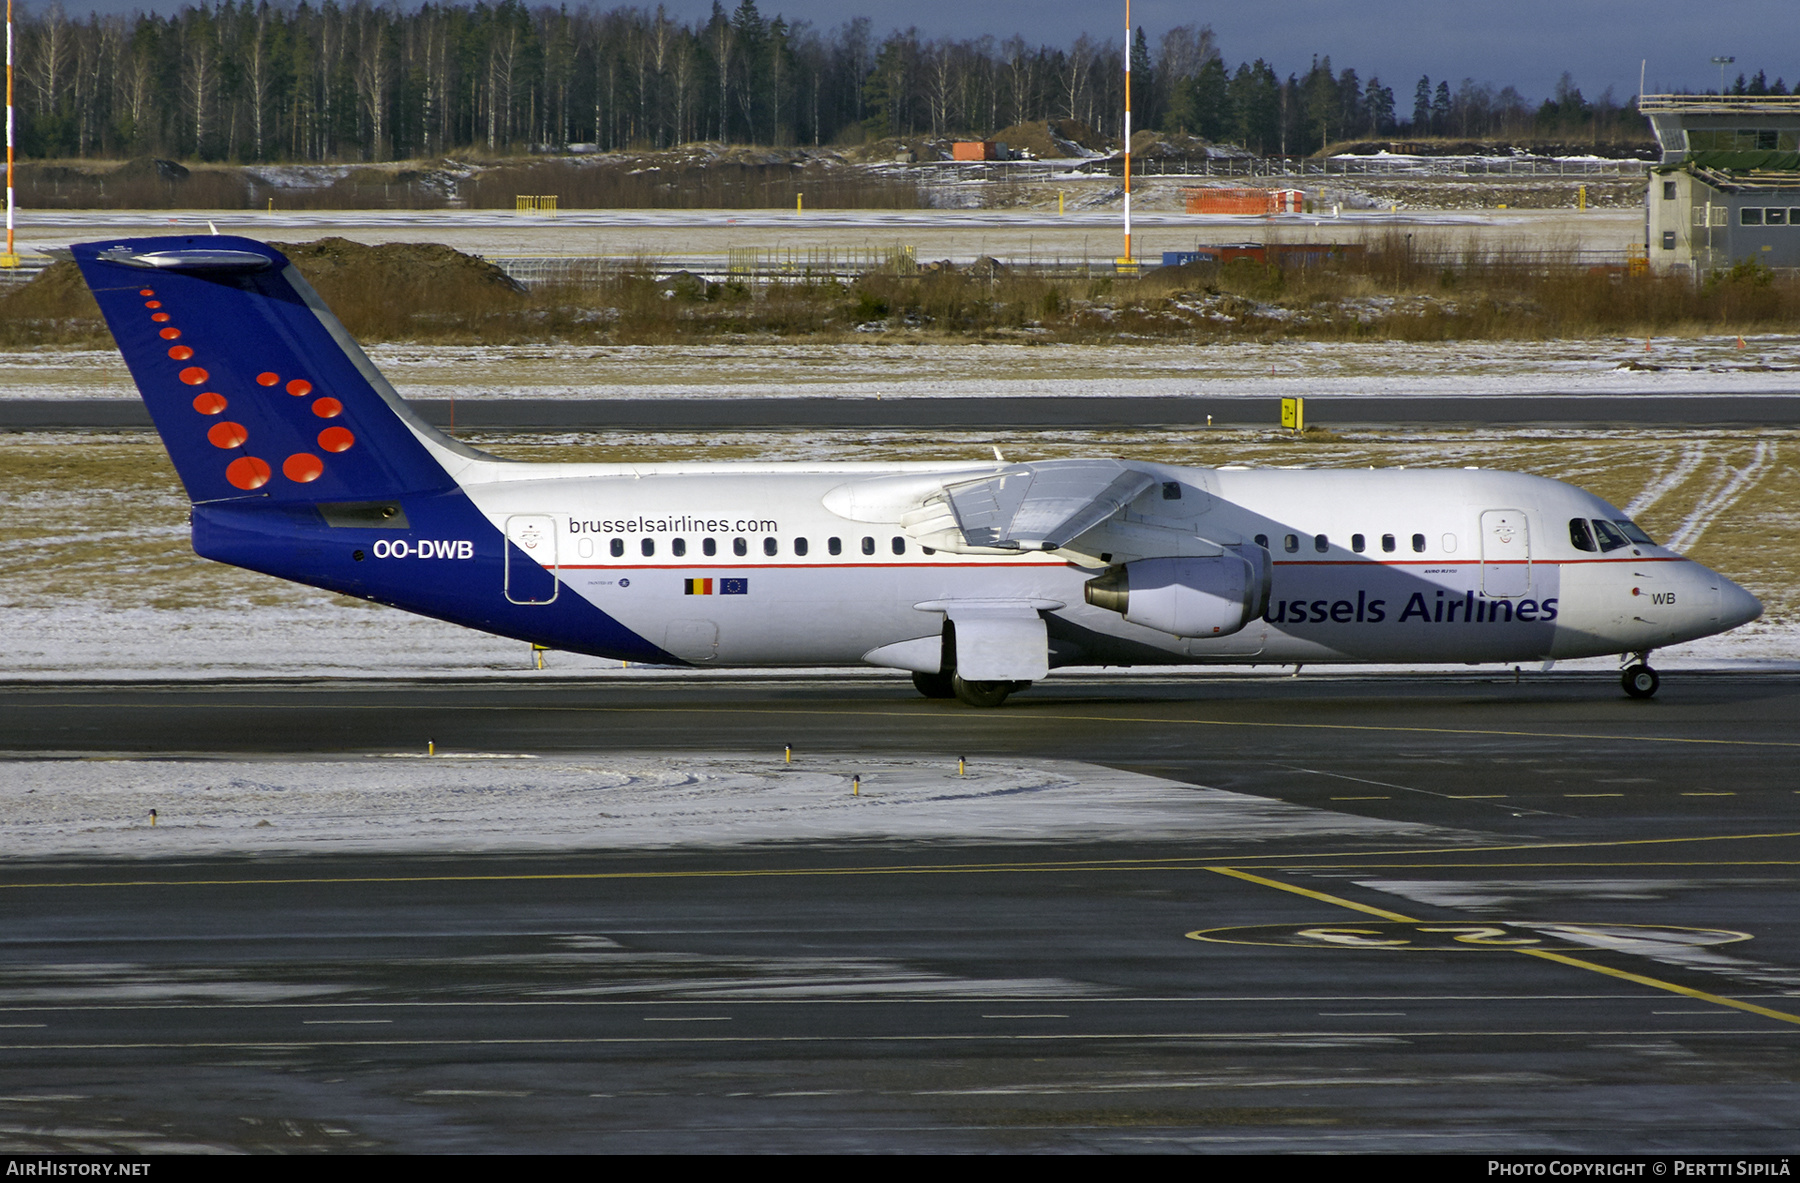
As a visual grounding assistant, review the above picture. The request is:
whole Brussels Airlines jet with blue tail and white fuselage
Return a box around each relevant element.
[74,236,1762,706]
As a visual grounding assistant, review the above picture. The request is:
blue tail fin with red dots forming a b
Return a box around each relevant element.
[74,236,466,504]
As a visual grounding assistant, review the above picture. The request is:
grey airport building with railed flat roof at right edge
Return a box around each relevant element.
[1638,94,1800,279]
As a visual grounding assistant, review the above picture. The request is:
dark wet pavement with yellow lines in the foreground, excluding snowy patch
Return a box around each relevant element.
[0,672,1800,1152]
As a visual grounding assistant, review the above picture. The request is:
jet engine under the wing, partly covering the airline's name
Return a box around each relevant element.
[1084,546,1269,637]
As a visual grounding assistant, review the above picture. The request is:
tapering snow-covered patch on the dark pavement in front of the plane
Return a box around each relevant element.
[0,751,1474,859]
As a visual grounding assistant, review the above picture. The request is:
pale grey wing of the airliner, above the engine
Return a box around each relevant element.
[943,459,1156,551]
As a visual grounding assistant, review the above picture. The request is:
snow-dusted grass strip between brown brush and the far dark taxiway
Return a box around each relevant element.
[10,335,1800,398]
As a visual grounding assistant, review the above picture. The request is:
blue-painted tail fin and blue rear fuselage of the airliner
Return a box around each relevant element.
[74,236,675,663]
